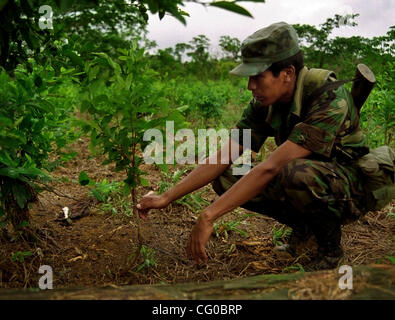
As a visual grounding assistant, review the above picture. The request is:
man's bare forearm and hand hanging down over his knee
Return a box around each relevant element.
[186,141,311,263]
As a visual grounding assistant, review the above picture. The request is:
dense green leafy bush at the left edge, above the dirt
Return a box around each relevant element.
[0,60,74,235]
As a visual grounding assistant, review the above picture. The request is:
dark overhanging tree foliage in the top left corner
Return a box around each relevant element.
[0,0,264,71]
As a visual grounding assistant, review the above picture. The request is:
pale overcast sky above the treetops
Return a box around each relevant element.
[148,0,395,53]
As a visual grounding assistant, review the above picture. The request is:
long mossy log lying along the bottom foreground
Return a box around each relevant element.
[0,265,395,300]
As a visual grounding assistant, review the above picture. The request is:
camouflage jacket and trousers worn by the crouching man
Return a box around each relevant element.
[218,60,371,255]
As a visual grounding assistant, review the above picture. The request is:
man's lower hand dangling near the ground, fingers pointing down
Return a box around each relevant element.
[186,212,214,264]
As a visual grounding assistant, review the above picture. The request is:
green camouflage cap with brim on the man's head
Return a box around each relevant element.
[230,22,300,76]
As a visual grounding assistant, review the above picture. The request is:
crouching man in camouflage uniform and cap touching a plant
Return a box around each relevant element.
[137,22,394,270]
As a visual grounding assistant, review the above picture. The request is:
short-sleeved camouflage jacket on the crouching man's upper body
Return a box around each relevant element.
[237,67,369,162]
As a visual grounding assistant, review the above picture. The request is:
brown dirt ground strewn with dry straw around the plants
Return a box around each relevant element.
[0,139,395,288]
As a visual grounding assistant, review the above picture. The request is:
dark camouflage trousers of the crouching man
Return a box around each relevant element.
[212,159,368,251]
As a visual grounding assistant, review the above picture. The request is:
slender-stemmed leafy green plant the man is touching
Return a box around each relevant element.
[76,42,184,257]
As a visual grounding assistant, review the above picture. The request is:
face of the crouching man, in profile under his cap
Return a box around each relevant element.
[248,70,288,107]
